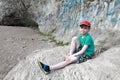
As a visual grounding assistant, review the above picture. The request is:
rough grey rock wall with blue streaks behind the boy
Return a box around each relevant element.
[0,0,120,41]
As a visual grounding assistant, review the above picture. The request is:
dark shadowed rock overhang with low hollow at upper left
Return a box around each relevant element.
[0,0,37,26]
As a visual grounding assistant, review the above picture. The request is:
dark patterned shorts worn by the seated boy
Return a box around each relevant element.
[74,46,92,63]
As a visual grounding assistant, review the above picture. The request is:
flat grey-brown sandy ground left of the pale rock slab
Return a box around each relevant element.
[0,26,55,80]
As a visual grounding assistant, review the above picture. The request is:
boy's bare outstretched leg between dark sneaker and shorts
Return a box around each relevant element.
[50,55,77,70]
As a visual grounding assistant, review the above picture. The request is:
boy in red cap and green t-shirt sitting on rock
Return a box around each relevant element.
[38,21,94,74]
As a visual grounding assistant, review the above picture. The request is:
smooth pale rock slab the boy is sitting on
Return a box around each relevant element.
[3,46,120,80]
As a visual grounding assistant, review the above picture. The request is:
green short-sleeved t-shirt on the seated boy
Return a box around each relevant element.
[78,34,94,57]
